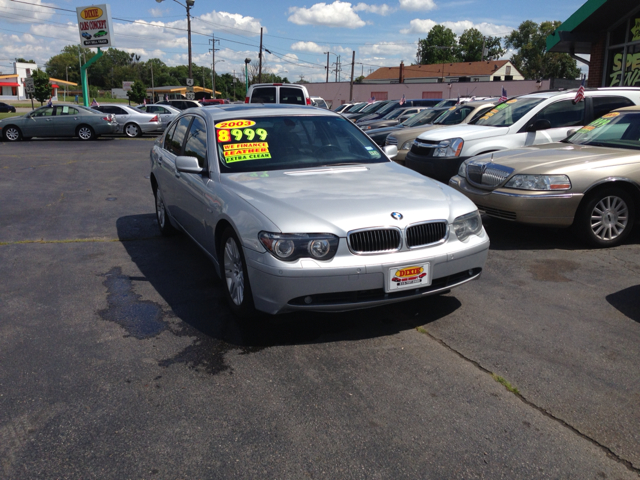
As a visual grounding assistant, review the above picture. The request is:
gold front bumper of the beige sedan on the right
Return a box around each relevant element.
[449,175,584,227]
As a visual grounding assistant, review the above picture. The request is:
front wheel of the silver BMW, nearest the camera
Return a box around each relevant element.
[218,227,257,320]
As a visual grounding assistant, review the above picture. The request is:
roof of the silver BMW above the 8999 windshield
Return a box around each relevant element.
[184,103,336,120]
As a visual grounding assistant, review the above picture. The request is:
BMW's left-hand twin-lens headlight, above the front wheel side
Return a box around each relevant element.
[258,232,339,262]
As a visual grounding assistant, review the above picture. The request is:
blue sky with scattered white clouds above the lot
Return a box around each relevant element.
[0,0,584,82]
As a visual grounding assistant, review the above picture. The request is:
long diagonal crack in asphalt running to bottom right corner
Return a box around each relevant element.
[416,327,640,475]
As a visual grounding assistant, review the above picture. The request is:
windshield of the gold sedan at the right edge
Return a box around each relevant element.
[563,112,640,150]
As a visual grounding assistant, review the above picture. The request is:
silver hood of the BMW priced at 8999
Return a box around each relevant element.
[222,162,475,237]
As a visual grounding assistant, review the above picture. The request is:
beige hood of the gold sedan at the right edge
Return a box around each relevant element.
[477,142,640,175]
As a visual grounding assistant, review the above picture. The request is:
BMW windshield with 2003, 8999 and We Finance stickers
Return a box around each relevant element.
[215,115,389,173]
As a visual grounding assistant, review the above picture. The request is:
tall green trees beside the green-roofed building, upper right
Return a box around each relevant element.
[504,20,580,80]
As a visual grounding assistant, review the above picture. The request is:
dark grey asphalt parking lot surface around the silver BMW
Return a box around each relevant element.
[0,138,640,479]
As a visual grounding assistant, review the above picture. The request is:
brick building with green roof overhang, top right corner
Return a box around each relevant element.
[547,0,640,87]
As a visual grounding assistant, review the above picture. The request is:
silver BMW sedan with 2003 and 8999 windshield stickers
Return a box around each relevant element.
[150,104,489,317]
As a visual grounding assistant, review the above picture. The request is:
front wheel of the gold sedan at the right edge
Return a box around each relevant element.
[574,187,636,248]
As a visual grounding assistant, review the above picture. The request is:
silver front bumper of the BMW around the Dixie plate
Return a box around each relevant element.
[244,229,489,314]
